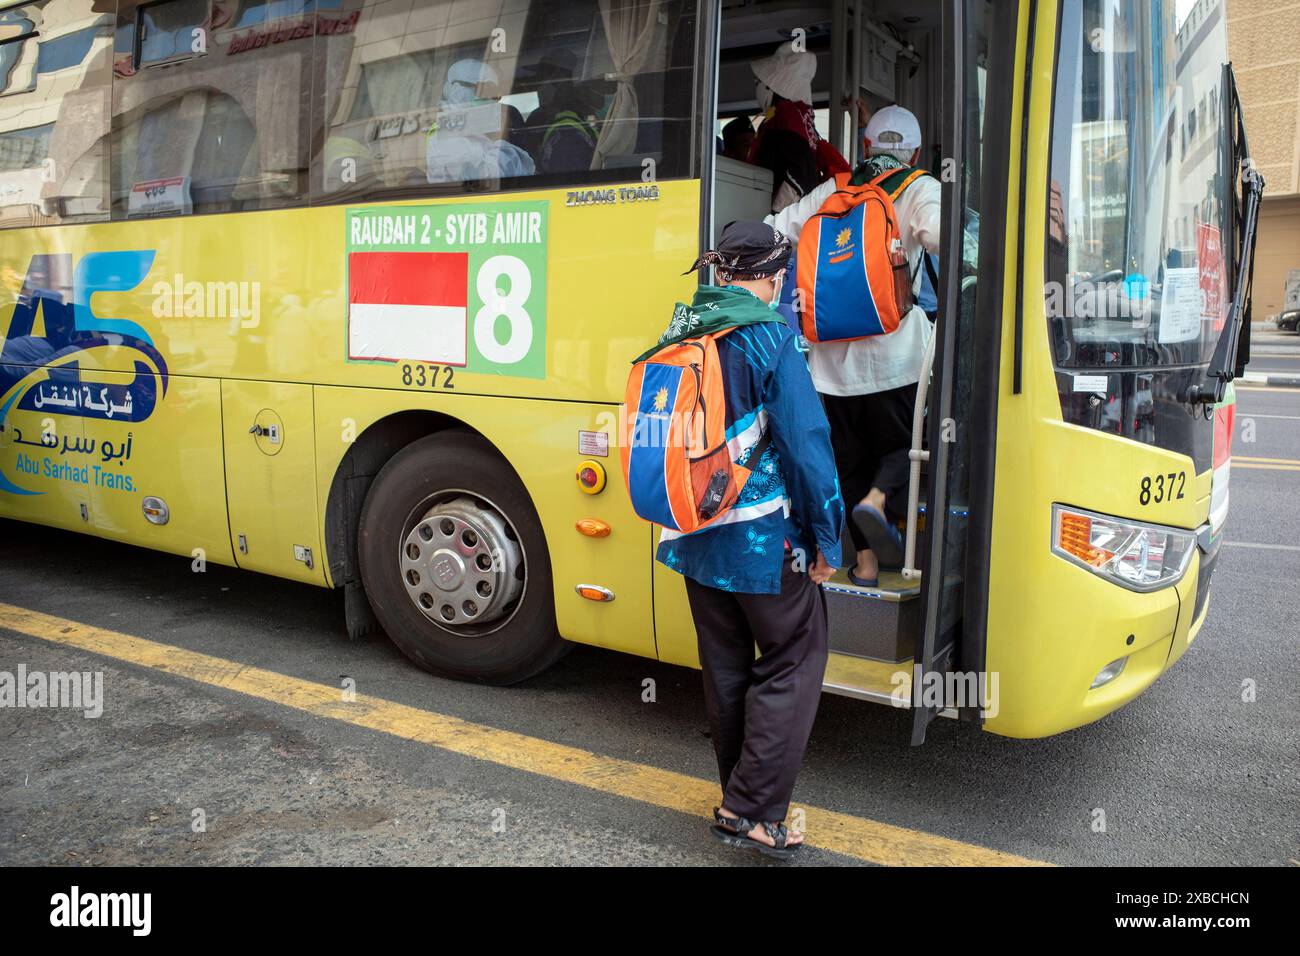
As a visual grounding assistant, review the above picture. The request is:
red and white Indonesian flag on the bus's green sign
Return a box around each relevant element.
[347,252,469,367]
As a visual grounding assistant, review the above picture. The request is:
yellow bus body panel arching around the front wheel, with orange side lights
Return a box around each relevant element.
[316,386,657,657]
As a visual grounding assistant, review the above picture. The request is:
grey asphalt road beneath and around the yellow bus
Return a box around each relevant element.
[0,379,1300,865]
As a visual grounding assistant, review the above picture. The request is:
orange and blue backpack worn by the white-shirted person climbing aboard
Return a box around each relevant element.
[796,168,928,342]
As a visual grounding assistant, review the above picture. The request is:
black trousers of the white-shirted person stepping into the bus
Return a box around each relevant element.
[822,382,917,551]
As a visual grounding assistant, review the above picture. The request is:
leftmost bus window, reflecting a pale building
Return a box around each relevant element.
[0,0,112,226]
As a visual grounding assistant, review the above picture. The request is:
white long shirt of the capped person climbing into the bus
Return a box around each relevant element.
[764,176,943,395]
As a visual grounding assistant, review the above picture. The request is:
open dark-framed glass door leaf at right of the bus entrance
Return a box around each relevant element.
[911,0,1008,744]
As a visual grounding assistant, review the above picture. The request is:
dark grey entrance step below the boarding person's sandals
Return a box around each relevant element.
[823,570,920,665]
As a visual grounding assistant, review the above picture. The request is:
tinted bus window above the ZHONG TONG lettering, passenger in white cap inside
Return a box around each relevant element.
[312,0,696,202]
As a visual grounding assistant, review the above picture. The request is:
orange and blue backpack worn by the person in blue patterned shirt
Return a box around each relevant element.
[620,329,767,535]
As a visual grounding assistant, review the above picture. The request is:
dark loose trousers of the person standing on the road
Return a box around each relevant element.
[686,555,827,822]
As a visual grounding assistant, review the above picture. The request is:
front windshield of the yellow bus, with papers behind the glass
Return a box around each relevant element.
[1045,0,1230,368]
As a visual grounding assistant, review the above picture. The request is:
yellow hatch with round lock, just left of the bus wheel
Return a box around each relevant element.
[221,380,323,584]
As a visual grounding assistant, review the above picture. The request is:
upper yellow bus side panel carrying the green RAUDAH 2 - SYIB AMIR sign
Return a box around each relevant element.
[50,179,699,402]
